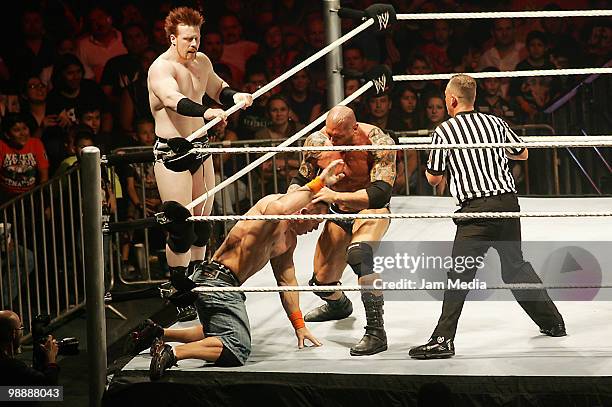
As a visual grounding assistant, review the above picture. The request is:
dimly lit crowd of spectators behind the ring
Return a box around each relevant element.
[0,0,612,278]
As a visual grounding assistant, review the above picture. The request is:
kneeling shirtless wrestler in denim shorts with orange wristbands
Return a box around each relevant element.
[130,160,344,379]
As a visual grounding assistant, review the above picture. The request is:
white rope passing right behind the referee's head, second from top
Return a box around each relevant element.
[393,68,612,82]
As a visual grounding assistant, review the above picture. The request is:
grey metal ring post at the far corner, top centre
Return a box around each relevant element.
[323,0,344,109]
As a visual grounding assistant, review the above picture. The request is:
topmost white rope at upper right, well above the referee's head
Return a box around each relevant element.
[397,10,612,20]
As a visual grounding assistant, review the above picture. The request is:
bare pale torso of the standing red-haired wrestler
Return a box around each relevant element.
[147,51,220,139]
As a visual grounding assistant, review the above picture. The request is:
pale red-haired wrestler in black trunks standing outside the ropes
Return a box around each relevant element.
[147,7,253,320]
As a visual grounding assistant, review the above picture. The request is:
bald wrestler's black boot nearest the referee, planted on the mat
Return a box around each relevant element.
[351,292,387,356]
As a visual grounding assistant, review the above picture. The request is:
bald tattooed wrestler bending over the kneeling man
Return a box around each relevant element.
[289,106,396,356]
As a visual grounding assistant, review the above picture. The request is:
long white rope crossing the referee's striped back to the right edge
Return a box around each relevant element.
[193,137,612,154]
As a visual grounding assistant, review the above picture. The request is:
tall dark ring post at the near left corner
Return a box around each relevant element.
[81,147,106,407]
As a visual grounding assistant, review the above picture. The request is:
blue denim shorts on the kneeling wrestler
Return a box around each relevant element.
[193,270,251,366]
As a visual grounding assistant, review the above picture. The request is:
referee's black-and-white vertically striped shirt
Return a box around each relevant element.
[427,111,523,204]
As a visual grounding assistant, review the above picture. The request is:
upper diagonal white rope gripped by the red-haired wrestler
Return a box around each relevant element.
[187,18,374,141]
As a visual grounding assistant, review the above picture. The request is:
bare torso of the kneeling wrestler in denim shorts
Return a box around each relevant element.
[212,195,297,284]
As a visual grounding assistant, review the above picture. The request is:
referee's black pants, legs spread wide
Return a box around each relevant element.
[432,193,563,338]
